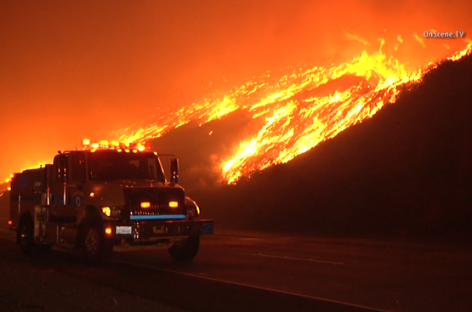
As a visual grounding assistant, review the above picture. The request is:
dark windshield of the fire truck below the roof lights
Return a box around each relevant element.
[88,150,165,182]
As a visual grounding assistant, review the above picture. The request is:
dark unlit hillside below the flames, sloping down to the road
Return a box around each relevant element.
[191,56,472,238]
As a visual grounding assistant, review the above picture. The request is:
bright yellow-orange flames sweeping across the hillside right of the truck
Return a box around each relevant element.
[113,40,472,183]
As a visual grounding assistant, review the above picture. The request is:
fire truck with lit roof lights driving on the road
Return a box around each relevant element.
[8,140,213,265]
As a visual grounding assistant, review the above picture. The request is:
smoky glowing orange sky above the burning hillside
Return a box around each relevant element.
[0,0,472,179]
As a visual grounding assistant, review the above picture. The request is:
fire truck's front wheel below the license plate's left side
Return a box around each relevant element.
[83,227,113,266]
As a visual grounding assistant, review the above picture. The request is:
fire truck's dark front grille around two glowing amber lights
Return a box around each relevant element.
[124,188,185,216]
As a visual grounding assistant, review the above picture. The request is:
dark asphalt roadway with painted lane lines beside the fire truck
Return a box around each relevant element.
[0,230,472,312]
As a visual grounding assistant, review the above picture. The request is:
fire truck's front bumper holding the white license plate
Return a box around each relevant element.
[106,220,214,244]
